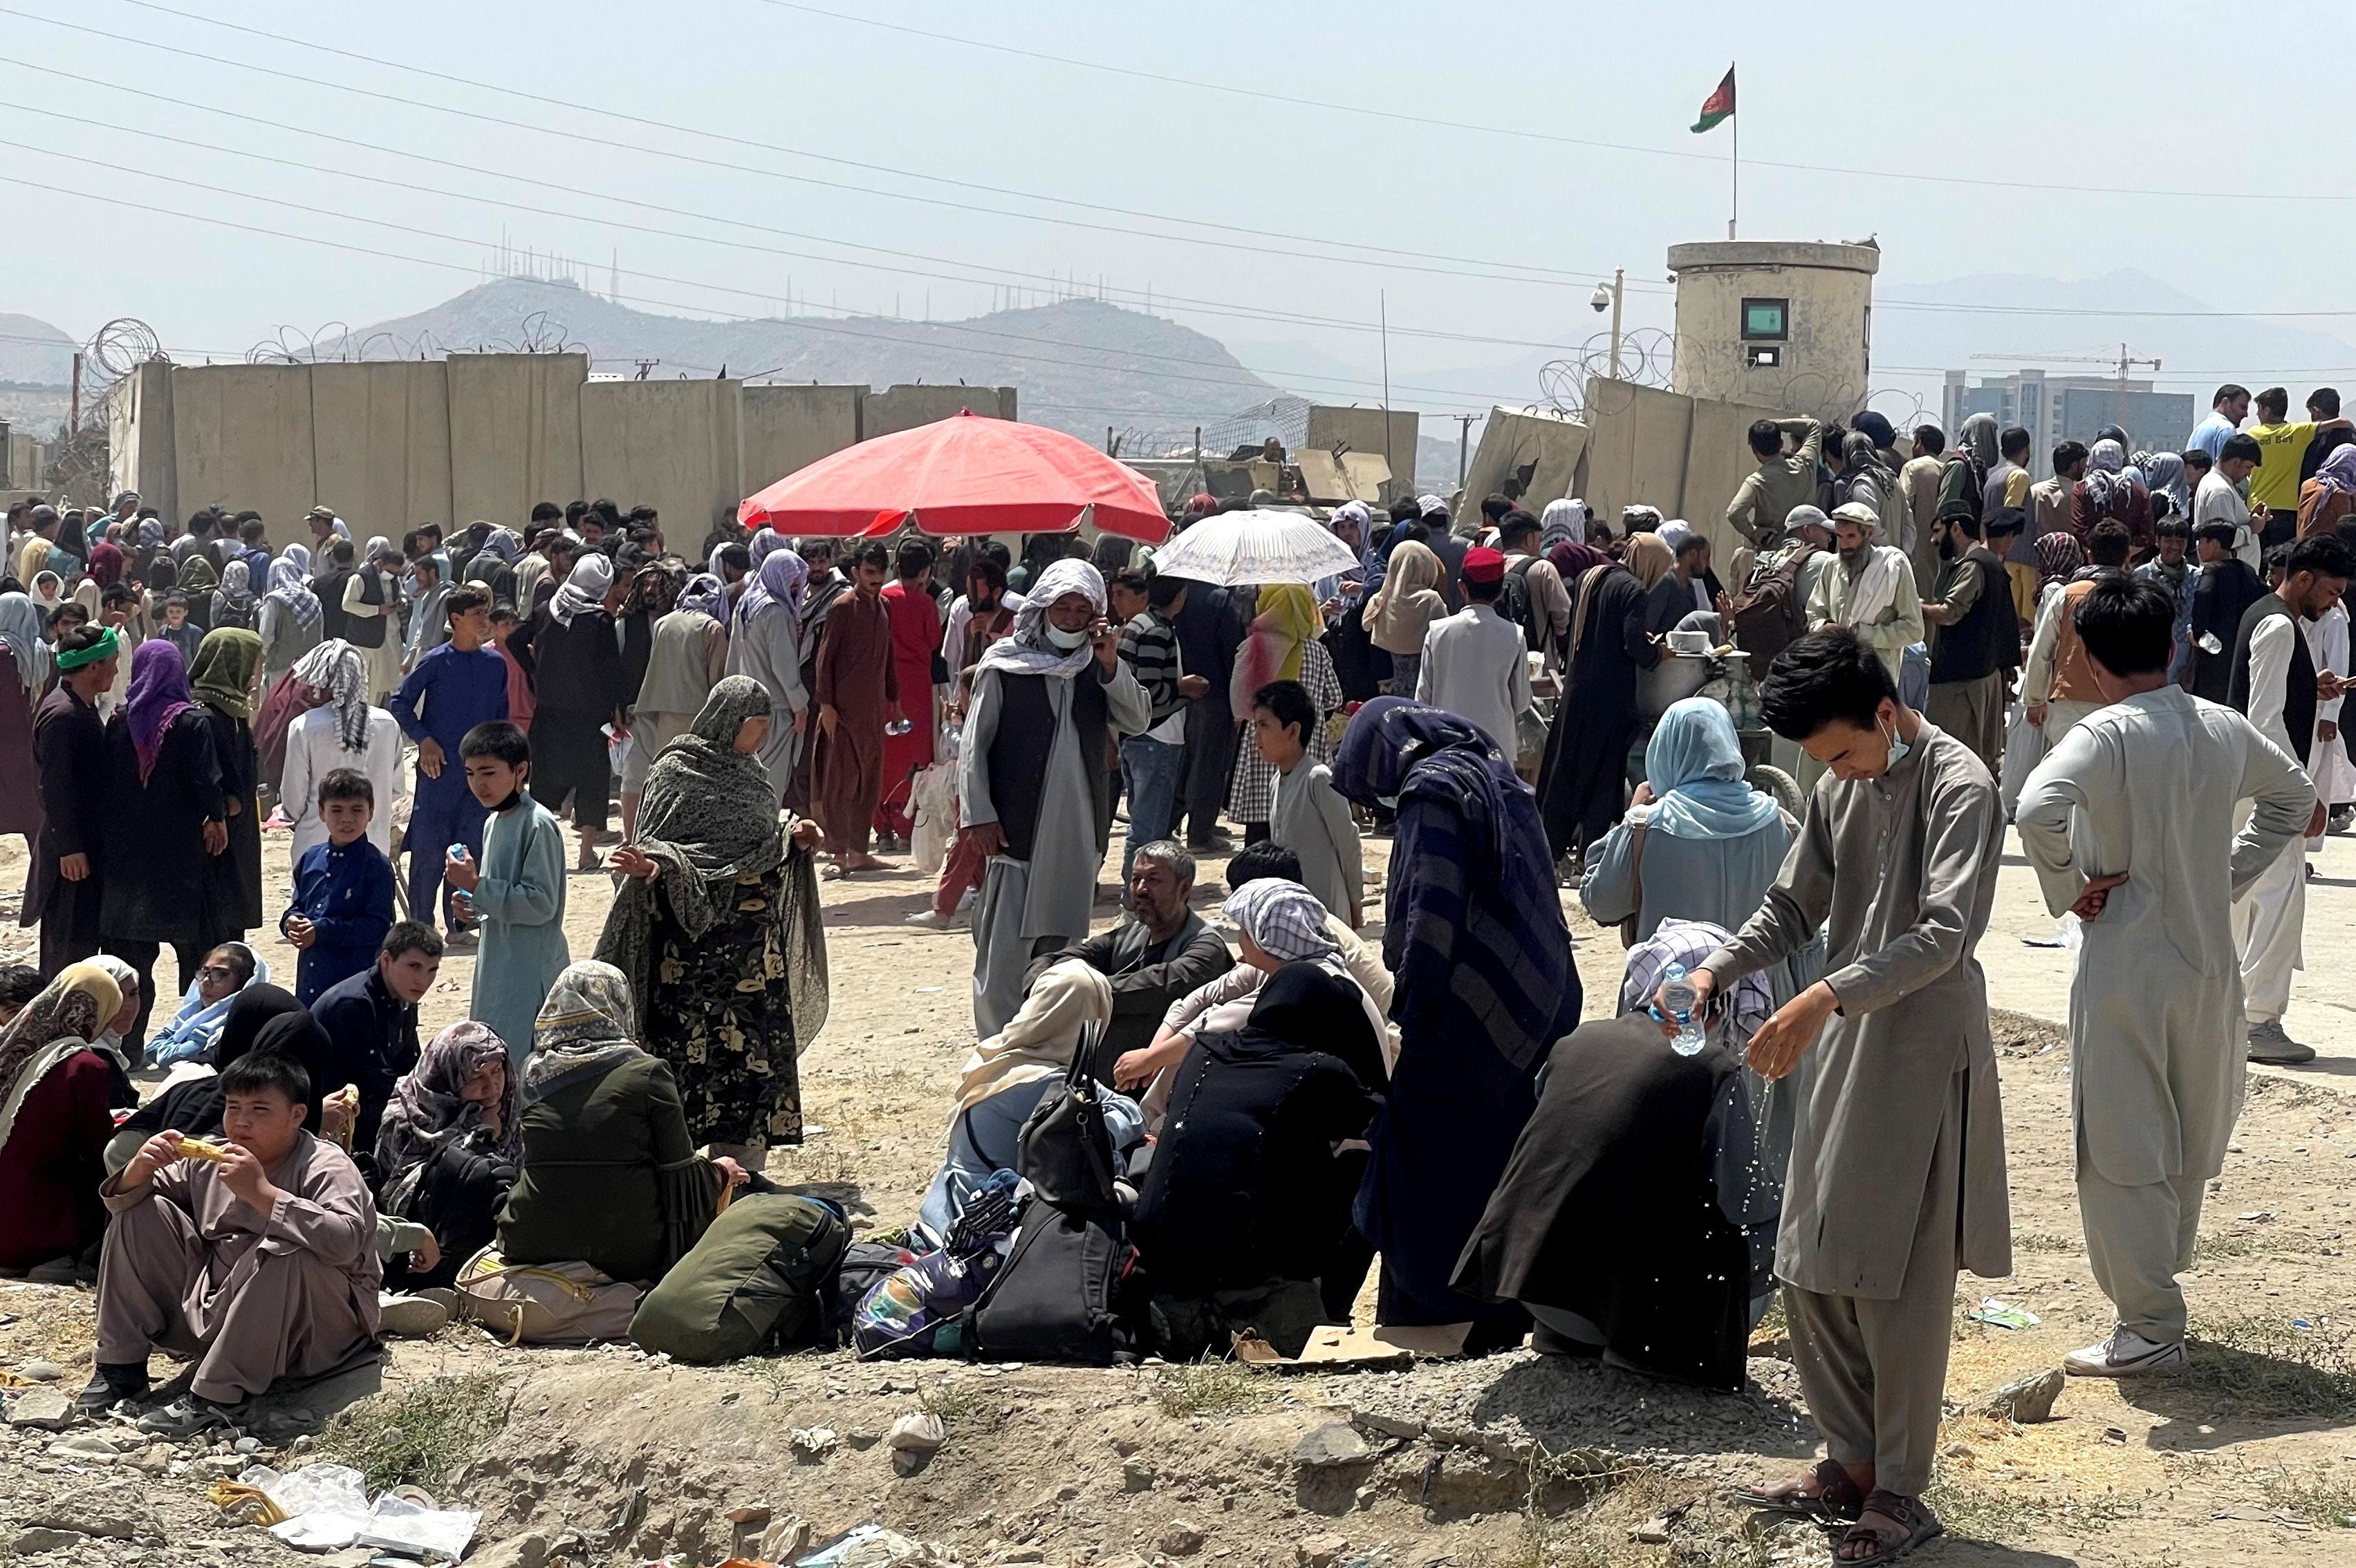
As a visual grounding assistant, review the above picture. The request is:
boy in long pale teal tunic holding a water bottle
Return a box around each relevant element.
[443,720,573,1071]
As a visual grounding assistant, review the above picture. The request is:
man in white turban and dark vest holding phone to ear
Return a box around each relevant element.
[956,560,1152,1038]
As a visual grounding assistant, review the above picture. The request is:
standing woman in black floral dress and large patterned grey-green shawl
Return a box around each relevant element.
[596,675,827,1168]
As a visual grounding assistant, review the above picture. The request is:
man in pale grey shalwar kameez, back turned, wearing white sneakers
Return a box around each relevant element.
[2014,577,2316,1377]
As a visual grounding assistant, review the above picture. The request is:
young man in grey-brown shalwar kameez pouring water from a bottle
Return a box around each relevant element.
[1694,626,2012,1551]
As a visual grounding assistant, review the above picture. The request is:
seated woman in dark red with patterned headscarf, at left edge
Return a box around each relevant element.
[0,963,127,1278]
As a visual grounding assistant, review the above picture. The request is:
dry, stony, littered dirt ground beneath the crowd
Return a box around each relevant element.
[0,796,2356,1568]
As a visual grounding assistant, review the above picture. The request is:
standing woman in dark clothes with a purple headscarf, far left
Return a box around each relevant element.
[99,638,236,1043]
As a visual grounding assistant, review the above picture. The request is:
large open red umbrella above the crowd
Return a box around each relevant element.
[737,410,1171,544]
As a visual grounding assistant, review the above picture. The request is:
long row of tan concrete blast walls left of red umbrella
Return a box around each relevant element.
[106,353,1015,548]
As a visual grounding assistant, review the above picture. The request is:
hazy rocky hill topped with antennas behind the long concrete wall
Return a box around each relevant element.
[320,278,1277,440]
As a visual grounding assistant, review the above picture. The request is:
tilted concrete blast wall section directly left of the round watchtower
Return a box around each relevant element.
[1583,377,1790,560]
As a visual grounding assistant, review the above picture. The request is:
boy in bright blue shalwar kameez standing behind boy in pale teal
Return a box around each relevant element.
[384,581,507,932]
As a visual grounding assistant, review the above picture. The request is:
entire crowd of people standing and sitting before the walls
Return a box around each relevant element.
[0,386,2356,1561]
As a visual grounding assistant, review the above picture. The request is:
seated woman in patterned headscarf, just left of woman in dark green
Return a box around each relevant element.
[377,1020,523,1290]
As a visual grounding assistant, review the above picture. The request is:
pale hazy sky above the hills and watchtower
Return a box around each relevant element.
[0,0,2356,414]
